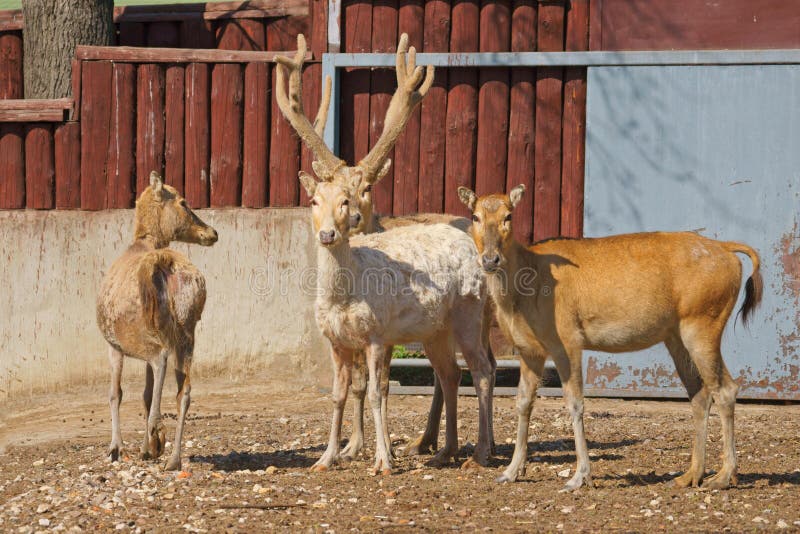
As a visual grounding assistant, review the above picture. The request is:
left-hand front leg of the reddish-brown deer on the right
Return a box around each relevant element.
[497,352,546,482]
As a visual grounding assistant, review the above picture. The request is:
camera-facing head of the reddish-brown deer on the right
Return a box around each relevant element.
[458,185,525,273]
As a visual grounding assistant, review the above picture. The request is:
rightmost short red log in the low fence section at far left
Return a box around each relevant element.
[53,122,81,209]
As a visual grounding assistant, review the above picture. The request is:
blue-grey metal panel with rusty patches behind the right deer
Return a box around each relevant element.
[584,65,800,399]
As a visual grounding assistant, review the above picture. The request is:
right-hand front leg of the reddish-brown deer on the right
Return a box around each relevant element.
[553,349,591,491]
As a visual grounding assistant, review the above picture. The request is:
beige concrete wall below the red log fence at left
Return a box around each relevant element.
[0,208,330,400]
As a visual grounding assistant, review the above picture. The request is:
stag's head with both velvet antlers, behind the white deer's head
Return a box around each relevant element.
[275,33,434,233]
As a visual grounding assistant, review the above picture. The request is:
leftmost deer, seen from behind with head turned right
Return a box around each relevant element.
[97,171,218,470]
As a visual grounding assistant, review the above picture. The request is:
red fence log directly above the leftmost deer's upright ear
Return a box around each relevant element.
[136,64,165,197]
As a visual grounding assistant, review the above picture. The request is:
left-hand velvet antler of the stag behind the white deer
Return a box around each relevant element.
[275,33,344,180]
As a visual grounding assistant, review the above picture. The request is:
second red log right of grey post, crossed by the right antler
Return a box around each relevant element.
[369,0,398,218]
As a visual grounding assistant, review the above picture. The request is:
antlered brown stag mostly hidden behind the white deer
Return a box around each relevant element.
[276,34,495,466]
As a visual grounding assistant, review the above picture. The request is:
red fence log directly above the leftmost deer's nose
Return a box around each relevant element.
[211,63,244,207]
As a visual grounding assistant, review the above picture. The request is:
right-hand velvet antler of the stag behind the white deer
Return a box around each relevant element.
[358,33,434,182]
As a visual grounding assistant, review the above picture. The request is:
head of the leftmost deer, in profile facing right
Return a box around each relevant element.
[134,171,218,248]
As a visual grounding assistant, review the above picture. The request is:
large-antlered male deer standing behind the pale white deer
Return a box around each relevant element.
[276,34,495,474]
